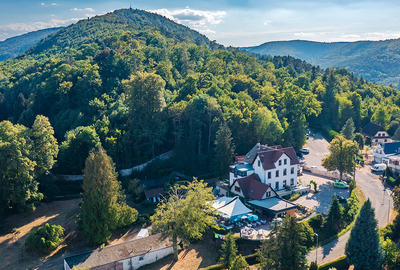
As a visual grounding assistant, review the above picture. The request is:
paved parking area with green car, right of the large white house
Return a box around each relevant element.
[294,173,350,214]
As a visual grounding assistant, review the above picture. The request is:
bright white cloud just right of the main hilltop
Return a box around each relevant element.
[150,6,226,34]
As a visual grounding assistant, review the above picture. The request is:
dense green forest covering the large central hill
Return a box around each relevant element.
[0,9,400,177]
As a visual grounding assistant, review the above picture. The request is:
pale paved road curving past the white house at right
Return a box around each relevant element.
[306,134,393,264]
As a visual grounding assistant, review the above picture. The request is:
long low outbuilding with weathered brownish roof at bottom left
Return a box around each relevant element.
[64,234,173,270]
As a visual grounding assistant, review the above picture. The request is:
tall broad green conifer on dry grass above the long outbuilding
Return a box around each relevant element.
[80,148,137,245]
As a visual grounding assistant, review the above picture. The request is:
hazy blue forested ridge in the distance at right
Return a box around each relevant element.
[242,39,400,89]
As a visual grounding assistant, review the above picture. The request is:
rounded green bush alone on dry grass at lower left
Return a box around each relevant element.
[25,223,64,253]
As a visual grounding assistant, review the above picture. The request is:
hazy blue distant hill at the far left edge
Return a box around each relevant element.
[0,27,62,61]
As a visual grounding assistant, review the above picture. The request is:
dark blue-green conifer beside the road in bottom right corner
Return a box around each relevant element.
[345,199,383,270]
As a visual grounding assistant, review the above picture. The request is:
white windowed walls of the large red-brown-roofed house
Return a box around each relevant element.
[253,153,298,191]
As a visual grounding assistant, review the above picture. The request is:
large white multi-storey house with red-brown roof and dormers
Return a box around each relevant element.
[229,143,300,191]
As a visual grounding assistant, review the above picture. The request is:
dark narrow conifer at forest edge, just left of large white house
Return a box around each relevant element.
[215,123,235,173]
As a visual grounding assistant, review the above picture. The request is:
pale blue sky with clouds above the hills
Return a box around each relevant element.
[0,0,400,46]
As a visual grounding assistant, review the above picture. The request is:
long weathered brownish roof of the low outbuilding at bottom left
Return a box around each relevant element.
[64,234,172,269]
